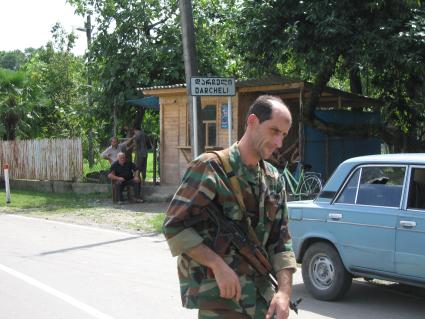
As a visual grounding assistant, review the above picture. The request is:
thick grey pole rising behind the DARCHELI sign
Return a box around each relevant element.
[179,0,205,157]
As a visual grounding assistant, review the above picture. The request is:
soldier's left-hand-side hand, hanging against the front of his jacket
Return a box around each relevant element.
[213,261,241,302]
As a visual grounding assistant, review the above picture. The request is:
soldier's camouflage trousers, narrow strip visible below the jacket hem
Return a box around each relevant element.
[198,296,269,319]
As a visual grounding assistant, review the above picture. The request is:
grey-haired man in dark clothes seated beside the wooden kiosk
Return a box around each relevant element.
[108,152,143,203]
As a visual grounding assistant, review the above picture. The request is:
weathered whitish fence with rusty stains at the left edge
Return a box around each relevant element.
[0,138,83,181]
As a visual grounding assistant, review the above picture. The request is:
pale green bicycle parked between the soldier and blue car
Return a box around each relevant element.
[281,162,322,200]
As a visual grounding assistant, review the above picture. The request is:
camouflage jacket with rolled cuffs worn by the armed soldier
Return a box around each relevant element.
[163,144,296,312]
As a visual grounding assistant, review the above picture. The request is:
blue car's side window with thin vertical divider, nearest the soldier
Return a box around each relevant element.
[336,166,406,207]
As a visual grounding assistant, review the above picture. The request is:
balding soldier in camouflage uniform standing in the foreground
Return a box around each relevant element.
[163,96,296,319]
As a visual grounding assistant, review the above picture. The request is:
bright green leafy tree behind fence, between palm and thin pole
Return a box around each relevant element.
[23,24,87,138]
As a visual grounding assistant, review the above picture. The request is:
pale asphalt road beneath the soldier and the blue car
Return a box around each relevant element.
[0,214,425,319]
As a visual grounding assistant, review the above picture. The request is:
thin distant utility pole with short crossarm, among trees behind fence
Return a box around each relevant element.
[77,12,94,168]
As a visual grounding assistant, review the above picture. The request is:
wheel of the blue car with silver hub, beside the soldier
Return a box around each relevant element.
[302,243,352,300]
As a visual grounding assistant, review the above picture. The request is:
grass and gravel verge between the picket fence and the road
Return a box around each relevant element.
[0,190,167,233]
